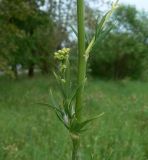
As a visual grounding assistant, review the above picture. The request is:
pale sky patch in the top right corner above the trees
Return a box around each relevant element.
[119,0,148,12]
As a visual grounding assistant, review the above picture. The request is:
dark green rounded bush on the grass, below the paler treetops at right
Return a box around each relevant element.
[91,33,147,79]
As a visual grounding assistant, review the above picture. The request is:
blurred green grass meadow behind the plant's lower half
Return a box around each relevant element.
[0,77,148,160]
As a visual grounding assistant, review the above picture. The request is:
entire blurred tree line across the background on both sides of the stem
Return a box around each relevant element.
[0,0,148,80]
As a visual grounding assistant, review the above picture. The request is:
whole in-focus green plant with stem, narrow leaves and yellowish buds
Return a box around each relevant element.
[40,0,118,160]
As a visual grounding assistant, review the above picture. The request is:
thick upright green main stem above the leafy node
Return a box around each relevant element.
[76,0,86,121]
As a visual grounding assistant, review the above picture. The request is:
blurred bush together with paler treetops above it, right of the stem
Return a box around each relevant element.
[90,6,148,79]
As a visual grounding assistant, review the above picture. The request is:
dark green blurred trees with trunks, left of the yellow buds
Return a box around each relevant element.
[0,0,69,76]
